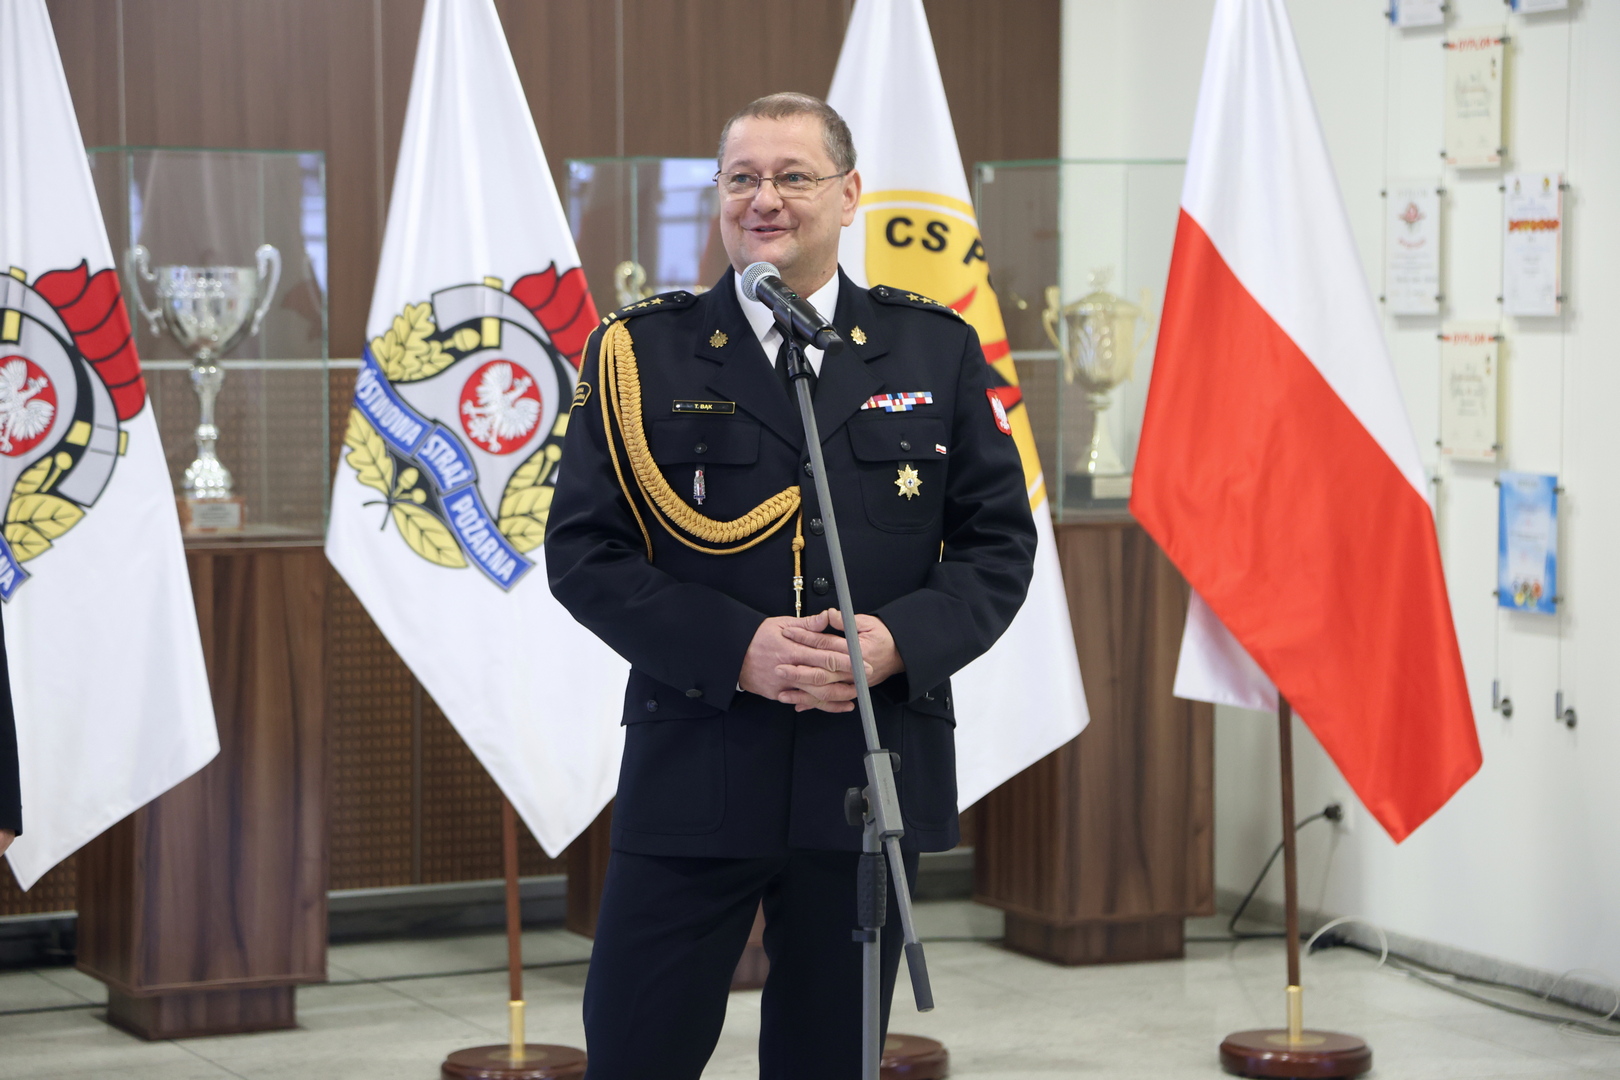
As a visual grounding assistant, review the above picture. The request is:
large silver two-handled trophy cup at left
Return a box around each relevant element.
[125,244,282,500]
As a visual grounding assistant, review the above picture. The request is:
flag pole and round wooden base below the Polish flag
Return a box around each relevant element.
[1220,705,1372,1077]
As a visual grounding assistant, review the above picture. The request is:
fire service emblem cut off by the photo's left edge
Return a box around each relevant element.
[0,262,146,601]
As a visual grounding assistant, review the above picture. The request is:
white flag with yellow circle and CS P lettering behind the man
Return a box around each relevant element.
[826,0,1089,806]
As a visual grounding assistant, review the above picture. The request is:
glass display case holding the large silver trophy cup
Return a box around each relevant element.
[89,146,330,542]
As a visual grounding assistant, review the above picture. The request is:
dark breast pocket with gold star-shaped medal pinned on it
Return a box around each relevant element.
[849,413,946,533]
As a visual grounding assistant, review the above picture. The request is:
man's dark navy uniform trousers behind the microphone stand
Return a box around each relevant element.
[585,848,917,1080]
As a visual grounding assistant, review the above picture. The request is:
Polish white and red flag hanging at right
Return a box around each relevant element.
[1131,0,1481,842]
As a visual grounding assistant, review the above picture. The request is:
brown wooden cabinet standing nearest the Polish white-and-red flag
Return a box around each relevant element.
[974,515,1215,963]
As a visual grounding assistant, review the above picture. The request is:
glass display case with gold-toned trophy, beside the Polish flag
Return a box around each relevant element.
[974,160,1184,520]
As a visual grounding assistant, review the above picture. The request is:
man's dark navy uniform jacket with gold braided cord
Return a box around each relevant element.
[546,270,1035,858]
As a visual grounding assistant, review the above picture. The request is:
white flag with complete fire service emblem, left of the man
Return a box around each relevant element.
[326,0,629,855]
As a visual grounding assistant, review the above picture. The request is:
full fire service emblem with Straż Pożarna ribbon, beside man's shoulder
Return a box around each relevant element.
[343,266,596,589]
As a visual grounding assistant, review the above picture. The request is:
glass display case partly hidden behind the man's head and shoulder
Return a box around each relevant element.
[564,157,727,314]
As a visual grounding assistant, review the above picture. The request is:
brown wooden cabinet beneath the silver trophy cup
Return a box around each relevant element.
[78,542,327,1040]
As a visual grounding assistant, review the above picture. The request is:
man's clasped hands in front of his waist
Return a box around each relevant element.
[737,607,906,712]
